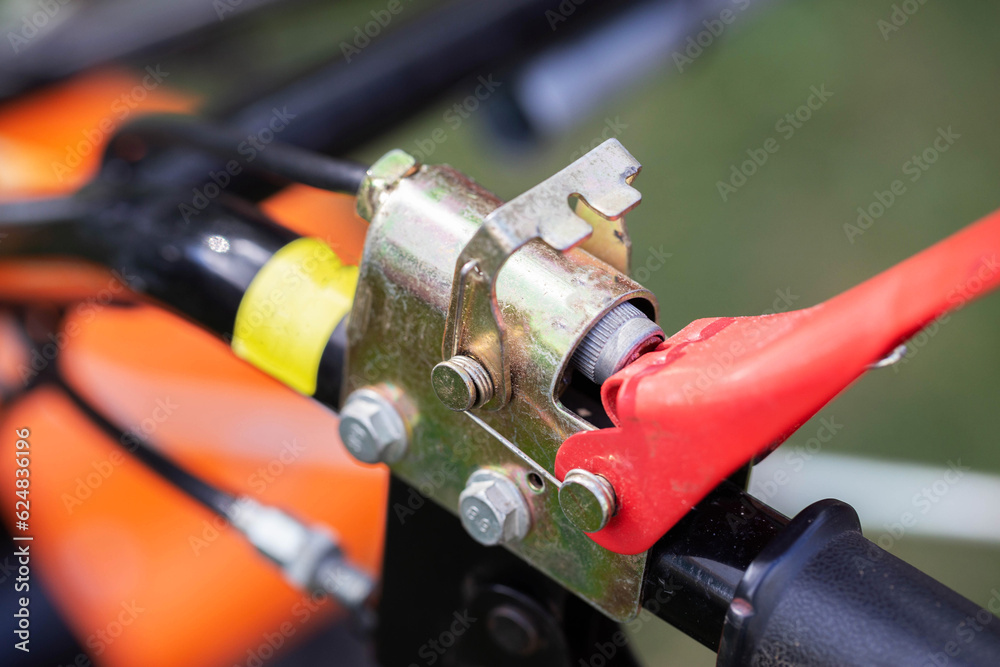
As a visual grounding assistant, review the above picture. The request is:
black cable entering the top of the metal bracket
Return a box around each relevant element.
[105,114,368,195]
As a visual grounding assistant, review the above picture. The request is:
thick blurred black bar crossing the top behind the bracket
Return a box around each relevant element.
[216,0,629,153]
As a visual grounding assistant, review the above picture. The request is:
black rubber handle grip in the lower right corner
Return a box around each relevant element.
[717,500,1000,667]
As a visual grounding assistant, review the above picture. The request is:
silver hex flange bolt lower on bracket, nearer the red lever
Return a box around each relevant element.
[458,470,531,546]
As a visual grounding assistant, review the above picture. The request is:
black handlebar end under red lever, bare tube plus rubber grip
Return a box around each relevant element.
[643,481,1000,667]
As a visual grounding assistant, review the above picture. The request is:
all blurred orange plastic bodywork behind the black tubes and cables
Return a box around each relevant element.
[0,73,388,667]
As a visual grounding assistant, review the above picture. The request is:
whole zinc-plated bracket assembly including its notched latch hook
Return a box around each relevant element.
[342,142,656,622]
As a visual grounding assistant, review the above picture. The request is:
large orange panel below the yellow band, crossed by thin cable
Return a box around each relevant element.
[0,307,387,666]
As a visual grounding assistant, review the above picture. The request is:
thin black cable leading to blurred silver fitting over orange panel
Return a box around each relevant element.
[51,372,236,520]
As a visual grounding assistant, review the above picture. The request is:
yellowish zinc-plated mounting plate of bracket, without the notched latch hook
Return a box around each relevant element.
[343,150,656,621]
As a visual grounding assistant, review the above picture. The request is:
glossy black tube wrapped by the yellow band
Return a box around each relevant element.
[0,190,347,409]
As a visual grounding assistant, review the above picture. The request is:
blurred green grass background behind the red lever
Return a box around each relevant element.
[180,0,1000,665]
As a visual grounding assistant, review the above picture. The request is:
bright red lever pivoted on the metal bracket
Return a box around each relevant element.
[556,211,1000,554]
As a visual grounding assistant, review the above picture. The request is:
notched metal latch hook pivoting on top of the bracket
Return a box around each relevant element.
[442,139,642,410]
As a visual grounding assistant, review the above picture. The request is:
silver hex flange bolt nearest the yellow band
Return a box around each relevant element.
[340,388,407,463]
